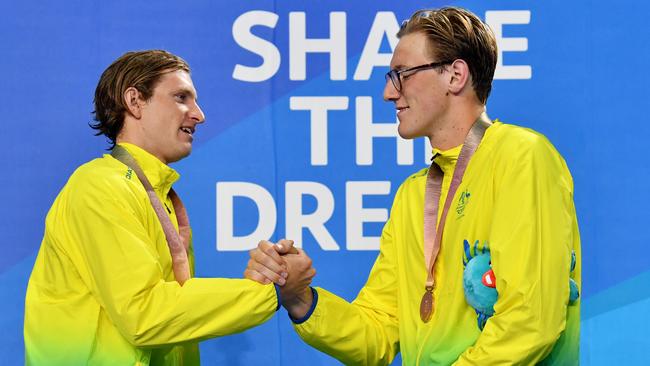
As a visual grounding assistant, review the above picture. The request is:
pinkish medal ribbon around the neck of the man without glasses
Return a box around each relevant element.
[111,145,190,286]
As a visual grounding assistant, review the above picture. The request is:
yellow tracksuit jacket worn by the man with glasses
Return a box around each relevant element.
[294,122,580,366]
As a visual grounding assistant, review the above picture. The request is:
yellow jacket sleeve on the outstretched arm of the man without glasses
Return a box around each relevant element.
[58,182,277,346]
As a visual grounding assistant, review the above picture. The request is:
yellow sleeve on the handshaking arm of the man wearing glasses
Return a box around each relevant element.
[294,212,399,365]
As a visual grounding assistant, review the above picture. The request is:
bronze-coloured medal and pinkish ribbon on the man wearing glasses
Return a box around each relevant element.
[420,113,492,323]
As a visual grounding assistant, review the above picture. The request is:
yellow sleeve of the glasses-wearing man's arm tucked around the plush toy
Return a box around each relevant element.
[455,137,579,366]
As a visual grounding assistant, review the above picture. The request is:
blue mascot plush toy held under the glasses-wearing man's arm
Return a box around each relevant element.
[463,240,580,330]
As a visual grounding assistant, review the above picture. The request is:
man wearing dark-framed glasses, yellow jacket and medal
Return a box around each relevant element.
[249,8,580,365]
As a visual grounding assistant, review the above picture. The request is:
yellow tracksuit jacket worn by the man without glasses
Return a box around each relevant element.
[24,144,278,365]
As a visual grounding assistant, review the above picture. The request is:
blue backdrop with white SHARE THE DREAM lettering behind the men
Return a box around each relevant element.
[0,0,650,365]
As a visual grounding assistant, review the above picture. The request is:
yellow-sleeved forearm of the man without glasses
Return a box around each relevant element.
[109,278,277,346]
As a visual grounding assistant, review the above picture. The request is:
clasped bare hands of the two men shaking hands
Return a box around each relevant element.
[244,239,316,319]
